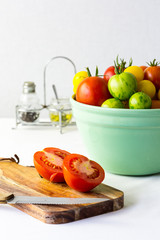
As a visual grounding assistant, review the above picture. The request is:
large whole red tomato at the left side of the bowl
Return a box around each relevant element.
[76,77,111,106]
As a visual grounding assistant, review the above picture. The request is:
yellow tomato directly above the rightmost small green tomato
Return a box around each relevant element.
[138,80,156,99]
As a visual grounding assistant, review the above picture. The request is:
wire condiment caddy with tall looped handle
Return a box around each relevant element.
[16,56,77,133]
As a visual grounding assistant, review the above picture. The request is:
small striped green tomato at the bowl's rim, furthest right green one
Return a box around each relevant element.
[129,92,152,109]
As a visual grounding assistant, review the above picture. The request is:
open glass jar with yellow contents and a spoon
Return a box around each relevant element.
[48,98,72,127]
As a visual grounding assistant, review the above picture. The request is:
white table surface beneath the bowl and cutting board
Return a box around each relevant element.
[0,118,160,240]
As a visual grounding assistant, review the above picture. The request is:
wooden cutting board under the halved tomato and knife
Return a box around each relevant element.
[0,161,124,224]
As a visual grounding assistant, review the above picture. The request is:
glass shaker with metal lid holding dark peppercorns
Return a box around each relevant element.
[17,82,42,123]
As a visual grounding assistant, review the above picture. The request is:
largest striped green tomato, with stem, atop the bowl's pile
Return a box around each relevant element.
[108,72,137,100]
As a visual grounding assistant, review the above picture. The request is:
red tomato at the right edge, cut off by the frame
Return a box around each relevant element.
[144,66,160,90]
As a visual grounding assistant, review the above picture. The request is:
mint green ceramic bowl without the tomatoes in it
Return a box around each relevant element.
[71,96,160,175]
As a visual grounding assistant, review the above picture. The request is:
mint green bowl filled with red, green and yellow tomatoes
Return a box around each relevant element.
[71,59,160,175]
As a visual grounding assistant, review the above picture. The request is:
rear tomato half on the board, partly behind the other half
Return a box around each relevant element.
[34,147,70,182]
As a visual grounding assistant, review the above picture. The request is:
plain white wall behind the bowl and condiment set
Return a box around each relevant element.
[0,0,160,117]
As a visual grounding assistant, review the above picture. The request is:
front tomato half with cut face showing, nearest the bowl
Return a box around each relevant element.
[63,154,105,192]
